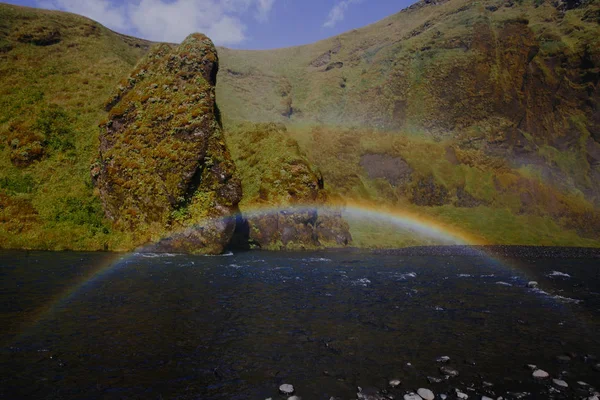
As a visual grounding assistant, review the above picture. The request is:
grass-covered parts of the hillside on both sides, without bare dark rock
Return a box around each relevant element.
[0,0,600,249]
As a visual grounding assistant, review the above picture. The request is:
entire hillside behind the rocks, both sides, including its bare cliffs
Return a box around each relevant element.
[0,0,600,250]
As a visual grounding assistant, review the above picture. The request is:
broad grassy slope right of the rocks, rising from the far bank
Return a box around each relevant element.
[217,0,600,247]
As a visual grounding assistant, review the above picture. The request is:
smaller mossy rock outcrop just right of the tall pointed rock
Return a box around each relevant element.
[227,123,352,250]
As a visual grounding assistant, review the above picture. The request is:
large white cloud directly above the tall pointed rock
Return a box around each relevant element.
[38,0,275,45]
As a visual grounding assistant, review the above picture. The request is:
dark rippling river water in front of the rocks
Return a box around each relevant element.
[0,251,600,399]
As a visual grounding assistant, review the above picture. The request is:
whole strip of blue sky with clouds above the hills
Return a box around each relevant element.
[1,0,415,49]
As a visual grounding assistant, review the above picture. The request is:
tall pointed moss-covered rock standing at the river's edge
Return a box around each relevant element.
[92,34,241,253]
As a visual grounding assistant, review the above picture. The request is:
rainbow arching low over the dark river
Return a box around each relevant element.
[8,202,505,342]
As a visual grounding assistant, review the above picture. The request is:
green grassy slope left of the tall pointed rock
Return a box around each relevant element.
[0,4,149,249]
